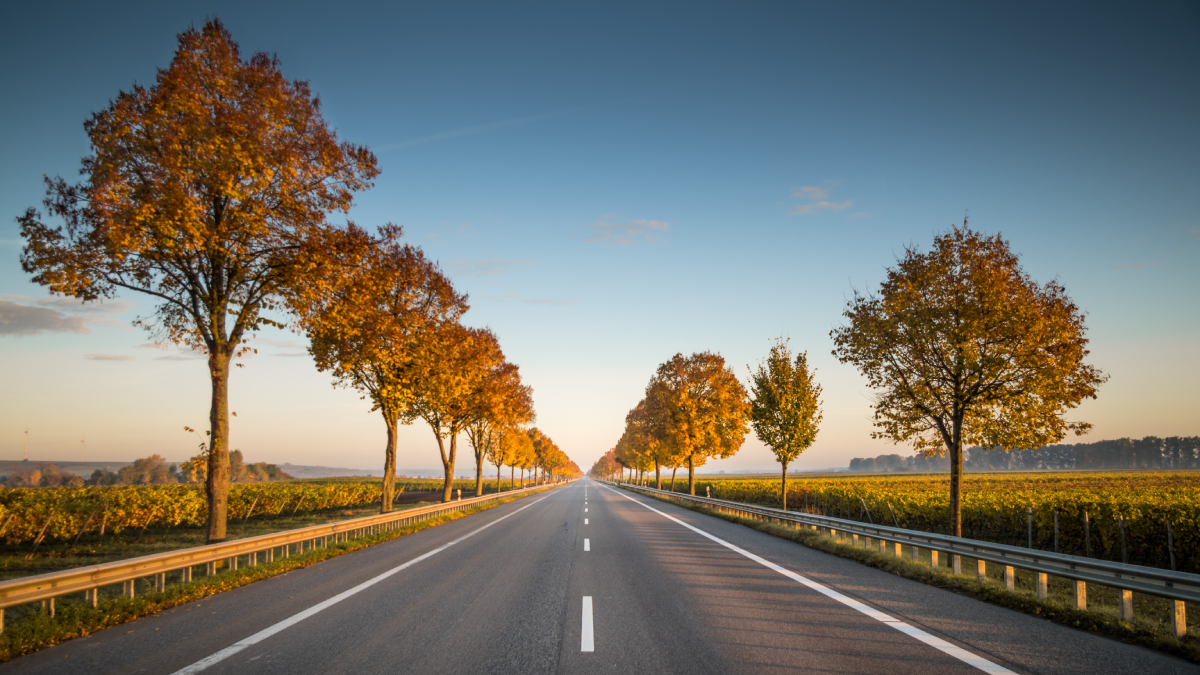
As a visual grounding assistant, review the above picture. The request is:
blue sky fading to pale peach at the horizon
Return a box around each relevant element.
[0,1,1200,473]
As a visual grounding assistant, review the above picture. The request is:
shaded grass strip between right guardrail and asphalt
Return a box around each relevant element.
[648,485,1200,663]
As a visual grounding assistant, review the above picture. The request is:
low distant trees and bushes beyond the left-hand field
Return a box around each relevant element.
[0,450,292,488]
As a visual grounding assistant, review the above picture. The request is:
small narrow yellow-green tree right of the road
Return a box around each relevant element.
[750,339,822,510]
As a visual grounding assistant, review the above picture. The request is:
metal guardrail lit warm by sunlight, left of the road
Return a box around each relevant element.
[0,482,565,633]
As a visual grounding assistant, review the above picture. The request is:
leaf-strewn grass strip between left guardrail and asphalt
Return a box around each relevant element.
[0,485,538,663]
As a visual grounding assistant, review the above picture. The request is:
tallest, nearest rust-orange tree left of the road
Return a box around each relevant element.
[18,19,378,543]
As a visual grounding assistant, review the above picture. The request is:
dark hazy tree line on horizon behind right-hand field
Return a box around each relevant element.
[850,436,1200,473]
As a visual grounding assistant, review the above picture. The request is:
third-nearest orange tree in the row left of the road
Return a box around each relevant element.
[402,323,504,502]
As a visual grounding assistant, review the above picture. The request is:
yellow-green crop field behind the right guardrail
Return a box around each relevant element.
[650,471,1200,573]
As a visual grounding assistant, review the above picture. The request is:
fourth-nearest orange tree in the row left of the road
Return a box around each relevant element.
[467,362,534,497]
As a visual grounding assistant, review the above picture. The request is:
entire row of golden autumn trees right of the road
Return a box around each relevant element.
[592,220,1108,536]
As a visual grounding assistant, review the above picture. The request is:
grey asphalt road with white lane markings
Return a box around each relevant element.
[2,480,1200,675]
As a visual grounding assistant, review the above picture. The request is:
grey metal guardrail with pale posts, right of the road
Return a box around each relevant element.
[618,483,1200,637]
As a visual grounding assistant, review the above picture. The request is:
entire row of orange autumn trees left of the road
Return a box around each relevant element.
[18,19,578,542]
